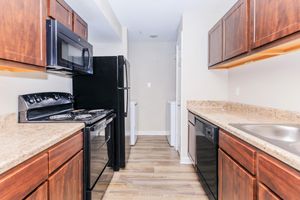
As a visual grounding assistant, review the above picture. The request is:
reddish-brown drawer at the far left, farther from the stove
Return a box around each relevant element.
[0,153,48,200]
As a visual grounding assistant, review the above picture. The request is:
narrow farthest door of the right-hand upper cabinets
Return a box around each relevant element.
[208,21,223,66]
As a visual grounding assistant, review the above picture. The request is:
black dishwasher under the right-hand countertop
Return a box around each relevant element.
[195,117,219,199]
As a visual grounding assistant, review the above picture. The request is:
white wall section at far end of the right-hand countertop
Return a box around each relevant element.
[180,8,228,163]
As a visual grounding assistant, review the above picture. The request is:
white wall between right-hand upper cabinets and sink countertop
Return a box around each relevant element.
[229,49,300,111]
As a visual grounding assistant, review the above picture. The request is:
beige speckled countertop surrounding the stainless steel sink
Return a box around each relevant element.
[187,101,300,171]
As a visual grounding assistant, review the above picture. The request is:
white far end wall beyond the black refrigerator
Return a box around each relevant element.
[129,42,176,133]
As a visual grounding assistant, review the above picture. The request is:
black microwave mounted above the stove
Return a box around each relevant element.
[46,19,93,76]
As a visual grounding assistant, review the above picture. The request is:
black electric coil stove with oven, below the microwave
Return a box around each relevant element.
[18,92,115,200]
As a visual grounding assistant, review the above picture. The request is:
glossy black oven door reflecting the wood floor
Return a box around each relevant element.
[87,120,111,189]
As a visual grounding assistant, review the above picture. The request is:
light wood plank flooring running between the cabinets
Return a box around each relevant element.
[103,136,208,200]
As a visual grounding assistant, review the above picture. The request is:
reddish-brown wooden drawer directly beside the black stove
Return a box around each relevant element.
[49,132,83,174]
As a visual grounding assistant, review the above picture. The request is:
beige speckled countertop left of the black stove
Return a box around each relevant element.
[0,114,84,174]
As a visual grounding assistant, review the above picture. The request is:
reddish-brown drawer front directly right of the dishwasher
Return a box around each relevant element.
[219,130,256,175]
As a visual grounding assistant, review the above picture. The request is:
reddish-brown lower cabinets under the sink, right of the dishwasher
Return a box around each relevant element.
[218,130,300,200]
